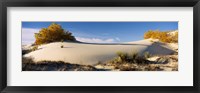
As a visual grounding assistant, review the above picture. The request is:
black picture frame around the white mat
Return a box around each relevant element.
[0,0,200,93]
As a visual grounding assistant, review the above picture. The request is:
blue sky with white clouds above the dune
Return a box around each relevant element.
[22,22,178,44]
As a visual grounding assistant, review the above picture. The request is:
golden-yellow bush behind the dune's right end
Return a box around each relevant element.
[144,30,178,43]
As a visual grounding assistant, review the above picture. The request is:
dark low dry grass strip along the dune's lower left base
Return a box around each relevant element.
[22,57,102,71]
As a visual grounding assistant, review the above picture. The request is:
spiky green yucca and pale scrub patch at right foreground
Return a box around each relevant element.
[97,52,178,71]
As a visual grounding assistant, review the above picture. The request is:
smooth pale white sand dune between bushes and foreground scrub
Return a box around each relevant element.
[24,39,177,65]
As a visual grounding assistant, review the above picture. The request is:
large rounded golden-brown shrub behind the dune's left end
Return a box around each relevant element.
[35,23,76,45]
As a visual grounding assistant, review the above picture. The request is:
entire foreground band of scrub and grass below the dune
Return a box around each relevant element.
[22,52,178,71]
